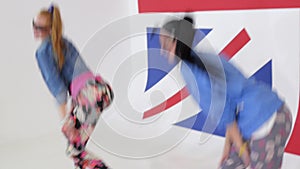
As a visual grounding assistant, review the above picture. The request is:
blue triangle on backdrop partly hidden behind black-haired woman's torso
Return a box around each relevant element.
[174,60,272,136]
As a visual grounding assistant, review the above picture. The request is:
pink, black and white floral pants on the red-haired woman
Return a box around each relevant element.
[62,76,113,169]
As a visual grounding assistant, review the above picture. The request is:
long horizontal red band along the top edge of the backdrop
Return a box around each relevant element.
[138,0,300,13]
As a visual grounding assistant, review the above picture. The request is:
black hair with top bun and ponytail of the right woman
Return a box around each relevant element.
[162,16,206,71]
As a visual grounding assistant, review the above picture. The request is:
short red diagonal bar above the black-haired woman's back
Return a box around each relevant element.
[220,29,250,59]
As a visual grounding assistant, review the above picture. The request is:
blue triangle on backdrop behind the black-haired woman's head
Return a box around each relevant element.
[145,28,212,91]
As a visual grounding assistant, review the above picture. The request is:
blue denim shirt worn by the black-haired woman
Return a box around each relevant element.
[181,52,283,139]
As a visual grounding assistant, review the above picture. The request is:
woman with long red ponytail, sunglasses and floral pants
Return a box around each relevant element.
[33,5,113,169]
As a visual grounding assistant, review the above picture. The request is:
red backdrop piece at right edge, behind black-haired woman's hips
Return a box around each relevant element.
[285,98,300,155]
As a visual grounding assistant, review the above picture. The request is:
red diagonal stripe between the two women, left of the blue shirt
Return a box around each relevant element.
[143,87,189,119]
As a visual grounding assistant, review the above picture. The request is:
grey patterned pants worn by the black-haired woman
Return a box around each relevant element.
[221,106,292,169]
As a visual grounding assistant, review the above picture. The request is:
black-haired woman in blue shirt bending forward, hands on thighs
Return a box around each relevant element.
[160,17,292,169]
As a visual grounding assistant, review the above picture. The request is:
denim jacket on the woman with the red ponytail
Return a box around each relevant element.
[36,37,90,104]
